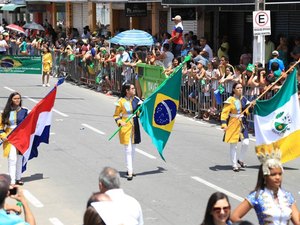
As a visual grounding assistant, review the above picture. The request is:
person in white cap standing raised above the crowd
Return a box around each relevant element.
[168,15,184,58]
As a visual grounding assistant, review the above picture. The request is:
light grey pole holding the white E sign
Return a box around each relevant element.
[252,0,266,65]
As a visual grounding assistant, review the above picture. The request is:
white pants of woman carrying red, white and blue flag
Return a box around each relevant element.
[8,145,23,184]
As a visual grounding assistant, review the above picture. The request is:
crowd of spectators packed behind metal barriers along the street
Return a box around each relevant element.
[0,21,300,117]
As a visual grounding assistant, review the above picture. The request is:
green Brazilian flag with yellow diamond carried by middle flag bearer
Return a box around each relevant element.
[140,67,182,160]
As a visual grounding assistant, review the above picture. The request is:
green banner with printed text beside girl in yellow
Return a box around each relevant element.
[0,55,42,75]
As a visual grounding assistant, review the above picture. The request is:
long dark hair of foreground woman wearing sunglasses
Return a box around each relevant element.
[201,192,230,225]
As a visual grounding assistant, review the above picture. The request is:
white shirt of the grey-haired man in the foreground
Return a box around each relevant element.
[100,189,144,225]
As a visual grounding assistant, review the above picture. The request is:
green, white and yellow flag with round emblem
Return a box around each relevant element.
[254,70,300,163]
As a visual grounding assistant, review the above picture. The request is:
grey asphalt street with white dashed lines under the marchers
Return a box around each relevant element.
[0,75,300,225]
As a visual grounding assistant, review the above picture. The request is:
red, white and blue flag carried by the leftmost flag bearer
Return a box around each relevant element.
[7,79,64,172]
